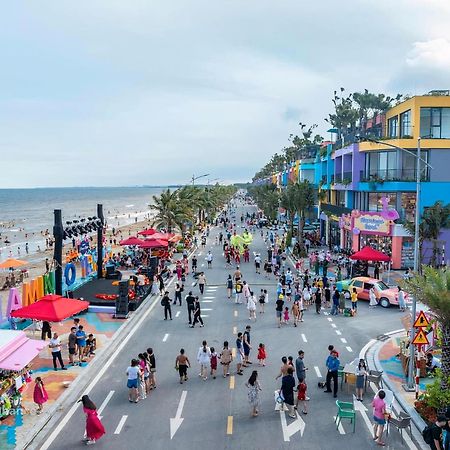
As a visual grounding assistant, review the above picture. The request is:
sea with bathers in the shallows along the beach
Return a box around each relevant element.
[0,187,168,261]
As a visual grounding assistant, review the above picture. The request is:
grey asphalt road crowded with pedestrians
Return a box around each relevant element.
[39,200,414,450]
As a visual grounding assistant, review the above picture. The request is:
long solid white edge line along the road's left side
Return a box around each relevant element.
[41,268,177,450]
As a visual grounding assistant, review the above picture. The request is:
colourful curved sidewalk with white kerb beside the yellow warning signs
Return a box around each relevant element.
[360,330,431,448]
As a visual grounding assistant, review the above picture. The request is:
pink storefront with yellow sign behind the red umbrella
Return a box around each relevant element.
[339,209,412,269]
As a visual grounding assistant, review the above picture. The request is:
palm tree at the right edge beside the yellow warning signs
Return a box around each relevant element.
[404,266,450,410]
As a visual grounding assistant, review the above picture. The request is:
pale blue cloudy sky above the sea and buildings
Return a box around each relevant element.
[0,0,450,188]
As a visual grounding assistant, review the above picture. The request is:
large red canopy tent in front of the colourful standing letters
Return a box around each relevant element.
[11,294,89,322]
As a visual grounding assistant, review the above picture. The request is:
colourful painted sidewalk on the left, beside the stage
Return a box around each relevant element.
[0,312,124,449]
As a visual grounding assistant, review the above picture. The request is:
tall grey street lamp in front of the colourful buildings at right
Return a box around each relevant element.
[362,136,433,391]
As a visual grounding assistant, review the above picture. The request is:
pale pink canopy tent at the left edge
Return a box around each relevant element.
[0,330,47,371]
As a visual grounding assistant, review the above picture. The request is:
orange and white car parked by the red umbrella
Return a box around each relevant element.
[336,277,409,308]
